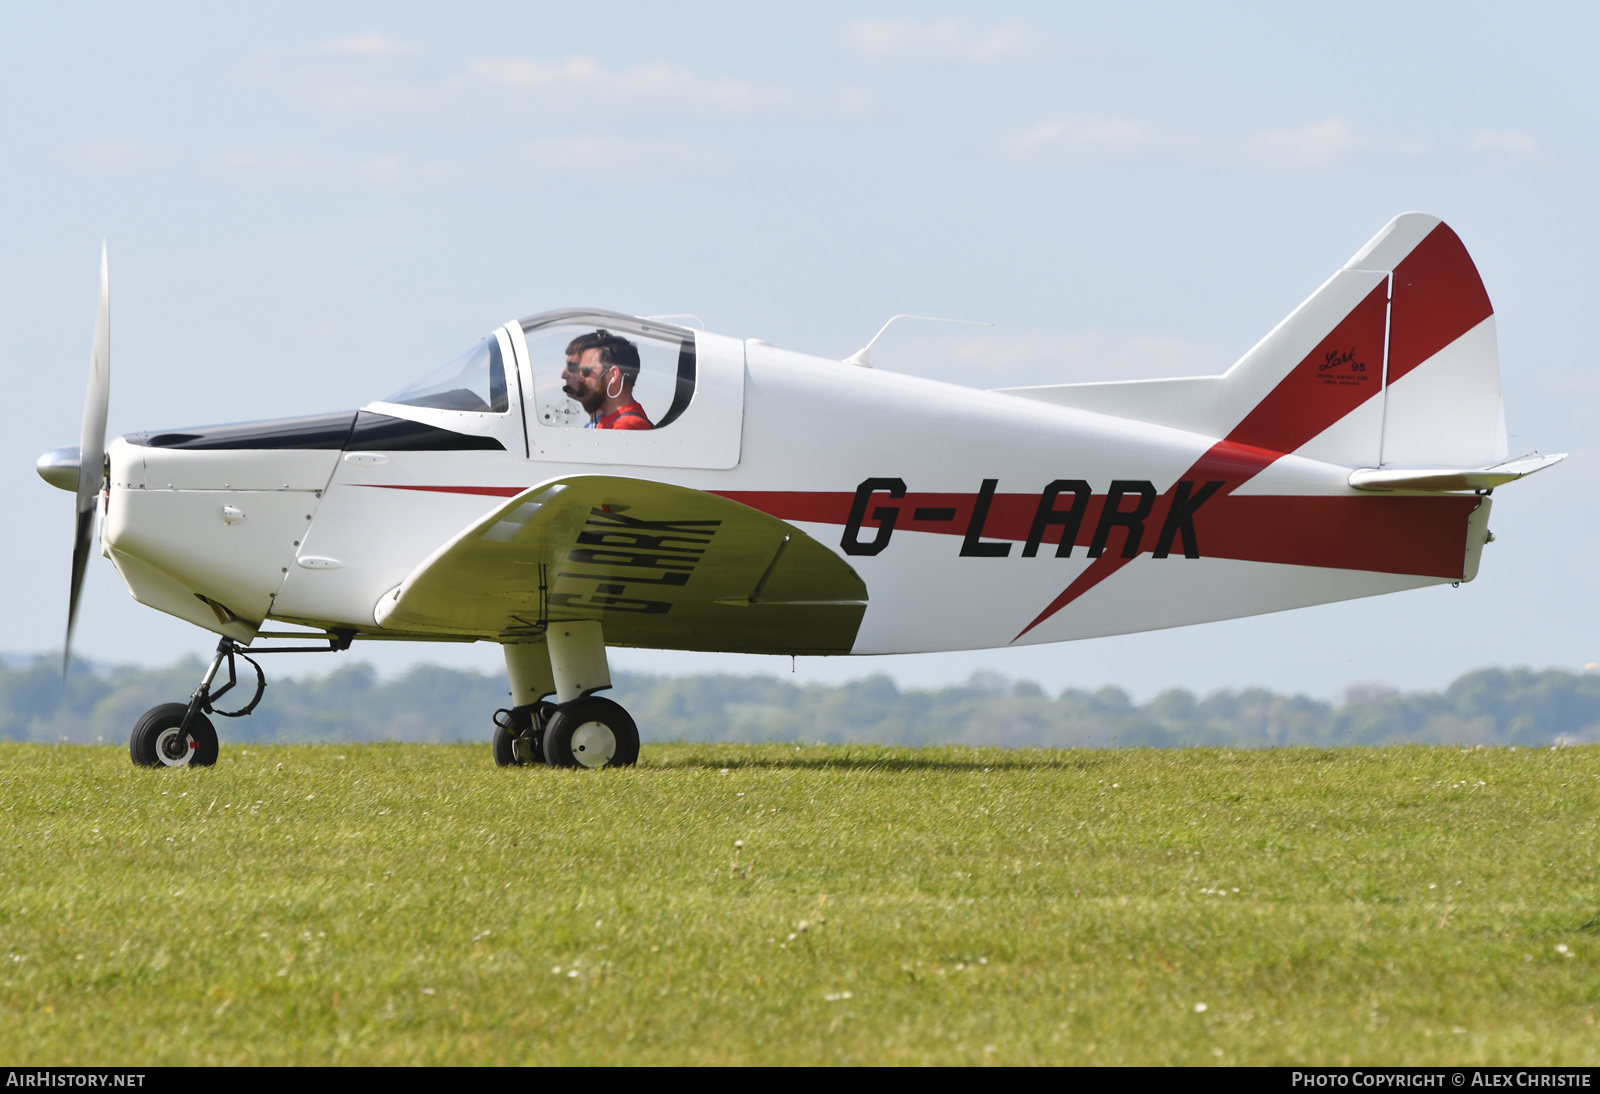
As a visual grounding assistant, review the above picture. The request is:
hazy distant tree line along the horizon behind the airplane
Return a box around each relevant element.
[0,657,1600,749]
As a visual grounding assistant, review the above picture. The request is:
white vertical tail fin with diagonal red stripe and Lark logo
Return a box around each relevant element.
[1003,213,1506,467]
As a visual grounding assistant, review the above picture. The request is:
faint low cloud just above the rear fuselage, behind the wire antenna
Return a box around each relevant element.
[872,331,1232,387]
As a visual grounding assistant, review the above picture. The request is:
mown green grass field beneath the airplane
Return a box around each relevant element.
[0,745,1600,1065]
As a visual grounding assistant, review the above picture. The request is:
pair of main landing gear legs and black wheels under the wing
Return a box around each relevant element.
[494,622,638,768]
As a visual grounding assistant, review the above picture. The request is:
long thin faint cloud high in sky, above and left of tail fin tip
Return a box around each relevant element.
[997,118,1424,170]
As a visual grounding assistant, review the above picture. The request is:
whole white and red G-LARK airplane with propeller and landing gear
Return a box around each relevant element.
[38,213,1562,766]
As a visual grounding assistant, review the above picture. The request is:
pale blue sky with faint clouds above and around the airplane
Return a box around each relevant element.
[0,3,1600,696]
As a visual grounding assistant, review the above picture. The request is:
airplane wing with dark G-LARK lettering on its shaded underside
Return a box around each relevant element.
[374,475,867,654]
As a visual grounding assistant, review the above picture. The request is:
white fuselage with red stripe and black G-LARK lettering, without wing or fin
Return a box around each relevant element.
[90,303,1488,654]
